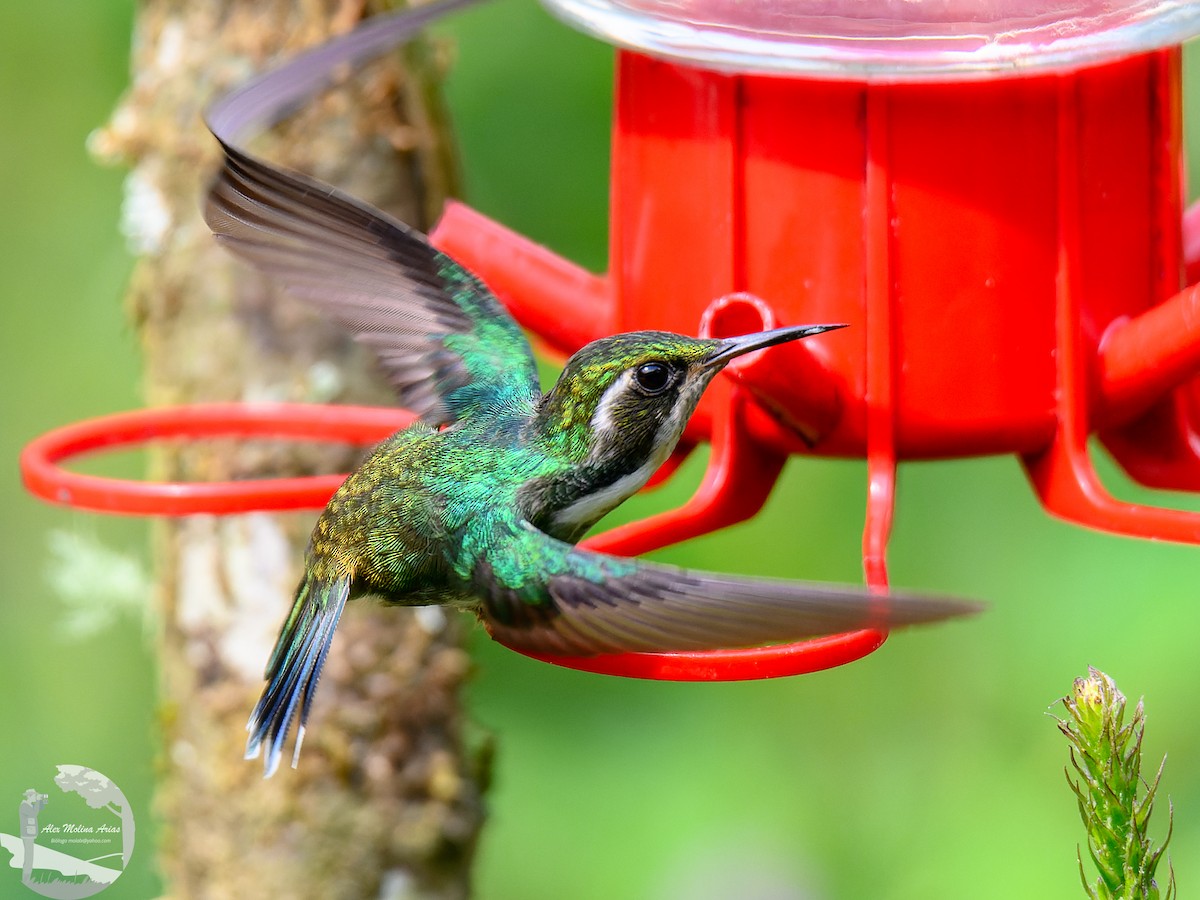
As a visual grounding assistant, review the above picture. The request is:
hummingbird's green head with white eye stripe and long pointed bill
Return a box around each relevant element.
[538,325,842,472]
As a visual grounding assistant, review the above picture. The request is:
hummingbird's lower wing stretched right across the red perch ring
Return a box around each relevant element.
[476,524,982,656]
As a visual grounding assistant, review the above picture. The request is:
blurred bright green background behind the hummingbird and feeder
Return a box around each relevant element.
[0,0,1200,900]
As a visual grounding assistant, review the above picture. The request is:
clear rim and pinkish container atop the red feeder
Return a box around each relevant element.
[542,0,1200,83]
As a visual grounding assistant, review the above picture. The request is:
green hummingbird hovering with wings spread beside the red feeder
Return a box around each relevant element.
[205,142,977,776]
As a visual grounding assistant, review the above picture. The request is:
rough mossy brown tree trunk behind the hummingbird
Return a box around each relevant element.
[94,0,482,898]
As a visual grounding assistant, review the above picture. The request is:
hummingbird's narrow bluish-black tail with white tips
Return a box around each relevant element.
[246,574,350,778]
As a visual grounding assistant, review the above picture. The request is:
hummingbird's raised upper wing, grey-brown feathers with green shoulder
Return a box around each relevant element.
[204,142,539,426]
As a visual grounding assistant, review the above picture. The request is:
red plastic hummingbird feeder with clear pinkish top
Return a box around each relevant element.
[18,0,1200,679]
